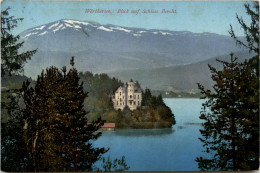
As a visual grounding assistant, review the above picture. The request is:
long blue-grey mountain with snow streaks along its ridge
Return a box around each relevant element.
[20,20,246,78]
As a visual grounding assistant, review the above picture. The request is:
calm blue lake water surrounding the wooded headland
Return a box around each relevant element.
[94,98,207,171]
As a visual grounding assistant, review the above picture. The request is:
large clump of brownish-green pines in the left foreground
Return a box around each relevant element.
[2,57,108,171]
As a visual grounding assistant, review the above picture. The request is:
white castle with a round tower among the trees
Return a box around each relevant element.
[112,80,142,111]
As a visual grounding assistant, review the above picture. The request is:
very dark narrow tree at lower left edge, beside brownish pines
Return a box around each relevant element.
[1,90,30,172]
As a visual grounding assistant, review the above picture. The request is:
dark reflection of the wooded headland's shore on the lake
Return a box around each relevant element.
[114,128,174,137]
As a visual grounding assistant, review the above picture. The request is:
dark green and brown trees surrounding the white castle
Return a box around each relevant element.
[80,72,176,128]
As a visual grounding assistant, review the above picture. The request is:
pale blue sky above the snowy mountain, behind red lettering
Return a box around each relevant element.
[1,0,253,36]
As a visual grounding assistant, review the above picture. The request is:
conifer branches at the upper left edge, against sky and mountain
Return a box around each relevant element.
[1,8,36,77]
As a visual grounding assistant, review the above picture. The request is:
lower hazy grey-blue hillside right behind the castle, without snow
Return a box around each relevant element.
[108,51,254,92]
